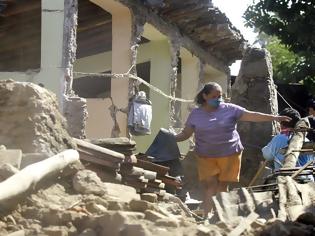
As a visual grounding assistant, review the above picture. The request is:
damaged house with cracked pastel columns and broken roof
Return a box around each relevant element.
[0,0,245,151]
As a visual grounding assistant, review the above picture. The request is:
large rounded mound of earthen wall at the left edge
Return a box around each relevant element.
[0,80,75,155]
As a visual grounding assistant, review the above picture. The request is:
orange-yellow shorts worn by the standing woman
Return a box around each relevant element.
[197,152,242,182]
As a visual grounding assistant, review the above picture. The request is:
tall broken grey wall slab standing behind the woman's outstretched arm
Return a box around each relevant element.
[232,47,278,185]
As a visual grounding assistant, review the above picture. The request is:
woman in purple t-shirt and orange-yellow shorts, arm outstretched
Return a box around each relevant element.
[175,82,290,217]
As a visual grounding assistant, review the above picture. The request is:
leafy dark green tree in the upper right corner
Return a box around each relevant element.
[244,0,315,93]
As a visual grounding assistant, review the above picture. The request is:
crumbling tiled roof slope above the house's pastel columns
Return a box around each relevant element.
[135,0,246,64]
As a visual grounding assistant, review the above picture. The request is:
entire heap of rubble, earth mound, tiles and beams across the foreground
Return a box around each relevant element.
[0,81,315,236]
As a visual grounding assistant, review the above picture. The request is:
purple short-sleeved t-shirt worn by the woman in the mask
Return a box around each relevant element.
[186,102,246,157]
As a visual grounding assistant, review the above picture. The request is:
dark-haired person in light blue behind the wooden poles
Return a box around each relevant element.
[262,108,314,174]
